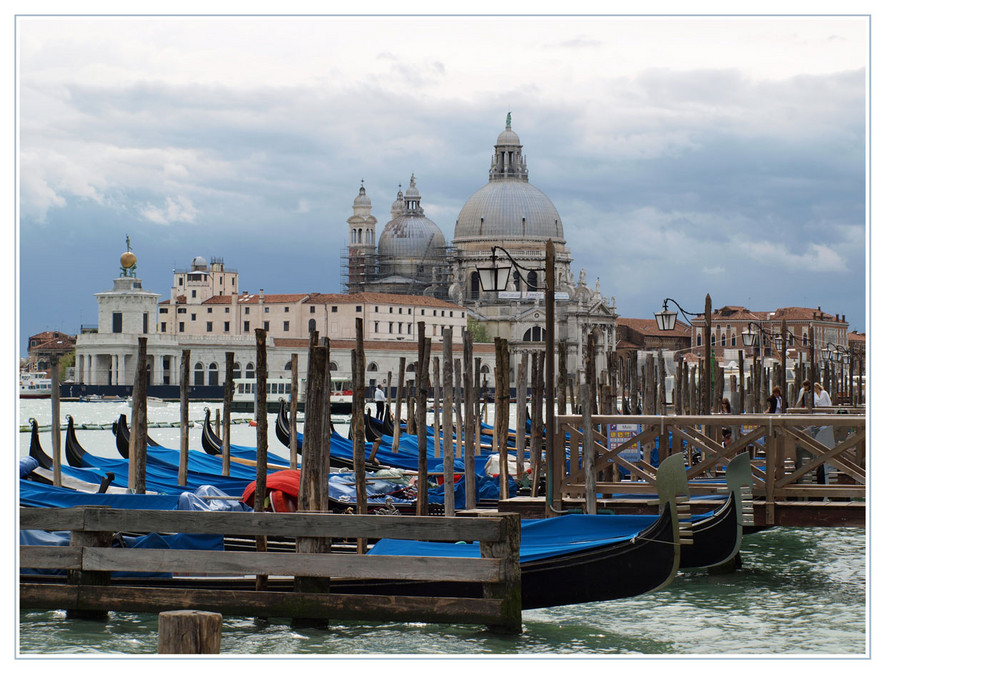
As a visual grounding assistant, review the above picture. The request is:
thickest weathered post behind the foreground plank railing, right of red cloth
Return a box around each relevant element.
[292,339,330,629]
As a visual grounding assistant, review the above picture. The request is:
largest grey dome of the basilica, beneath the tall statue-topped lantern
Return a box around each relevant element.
[452,180,566,244]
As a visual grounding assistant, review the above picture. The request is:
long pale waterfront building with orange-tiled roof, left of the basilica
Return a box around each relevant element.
[70,247,476,397]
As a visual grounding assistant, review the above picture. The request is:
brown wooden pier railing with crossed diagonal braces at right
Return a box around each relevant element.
[554,413,867,523]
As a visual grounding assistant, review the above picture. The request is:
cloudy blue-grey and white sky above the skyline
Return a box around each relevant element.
[16,16,869,355]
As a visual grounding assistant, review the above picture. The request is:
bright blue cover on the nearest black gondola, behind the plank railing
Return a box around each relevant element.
[368,515,656,563]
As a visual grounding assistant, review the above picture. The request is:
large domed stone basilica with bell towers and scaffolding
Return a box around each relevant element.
[344,113,617,373]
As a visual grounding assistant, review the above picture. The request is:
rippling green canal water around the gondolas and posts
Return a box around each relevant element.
[17,400,869,658]
